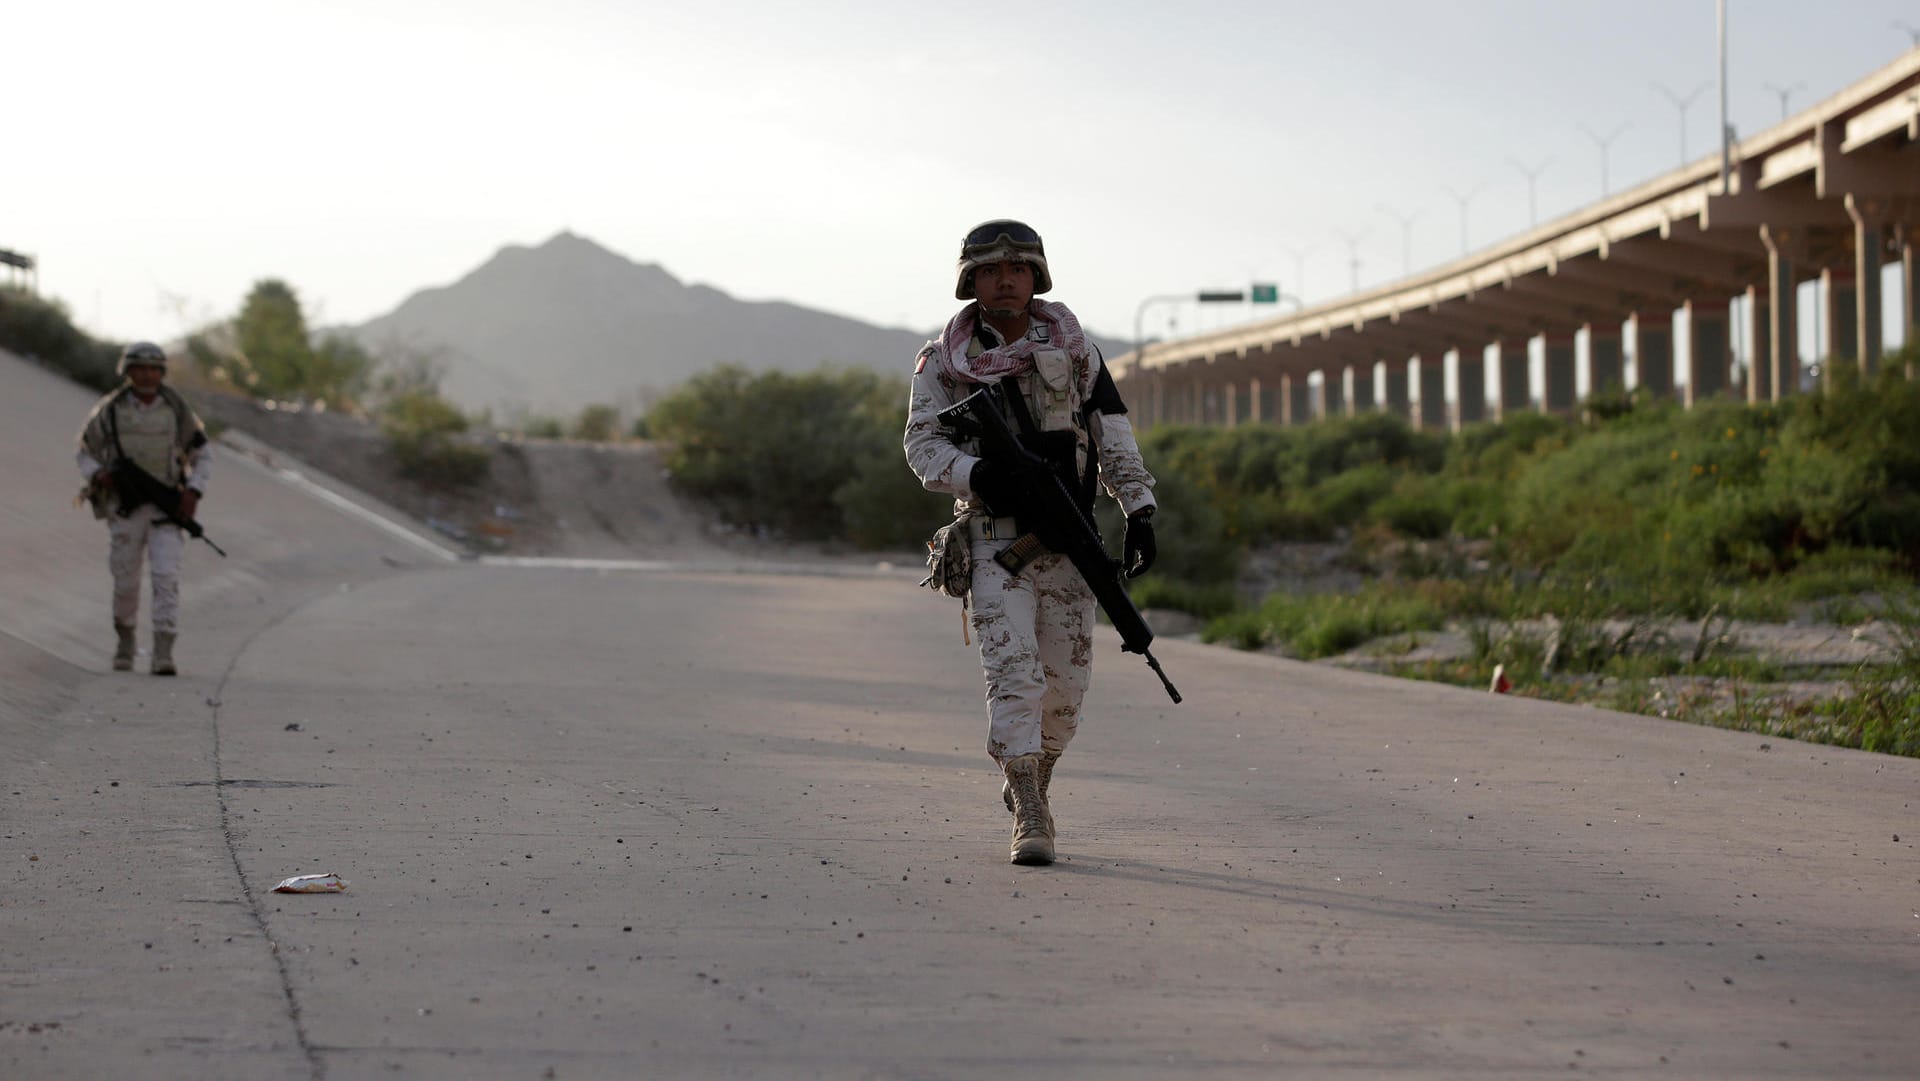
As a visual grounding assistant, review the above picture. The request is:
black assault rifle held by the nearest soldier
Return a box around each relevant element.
[939,384,1181,703]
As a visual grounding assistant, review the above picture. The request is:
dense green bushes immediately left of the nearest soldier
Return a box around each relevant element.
[647,367,950,549]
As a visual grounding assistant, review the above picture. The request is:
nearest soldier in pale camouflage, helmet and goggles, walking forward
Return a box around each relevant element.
[904,219,1154,864]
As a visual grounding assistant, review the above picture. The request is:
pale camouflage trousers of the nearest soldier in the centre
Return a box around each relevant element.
[972,540,1094,762]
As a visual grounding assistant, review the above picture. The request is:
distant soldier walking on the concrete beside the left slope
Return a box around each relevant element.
[75,342,213,676]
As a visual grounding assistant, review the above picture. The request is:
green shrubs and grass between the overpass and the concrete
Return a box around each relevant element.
[1113,346,1920,755]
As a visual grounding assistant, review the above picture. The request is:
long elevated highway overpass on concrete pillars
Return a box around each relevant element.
[1114,48,1920,428]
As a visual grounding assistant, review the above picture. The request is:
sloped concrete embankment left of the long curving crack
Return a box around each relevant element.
[0,353,444,1079]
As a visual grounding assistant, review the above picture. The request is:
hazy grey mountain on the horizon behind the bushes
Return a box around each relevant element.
[349,232,1125,417]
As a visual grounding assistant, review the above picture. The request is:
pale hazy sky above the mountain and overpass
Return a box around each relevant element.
[15,0,1920,353]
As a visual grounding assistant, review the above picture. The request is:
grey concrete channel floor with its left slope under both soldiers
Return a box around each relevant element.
[0,351,1920,1081]
